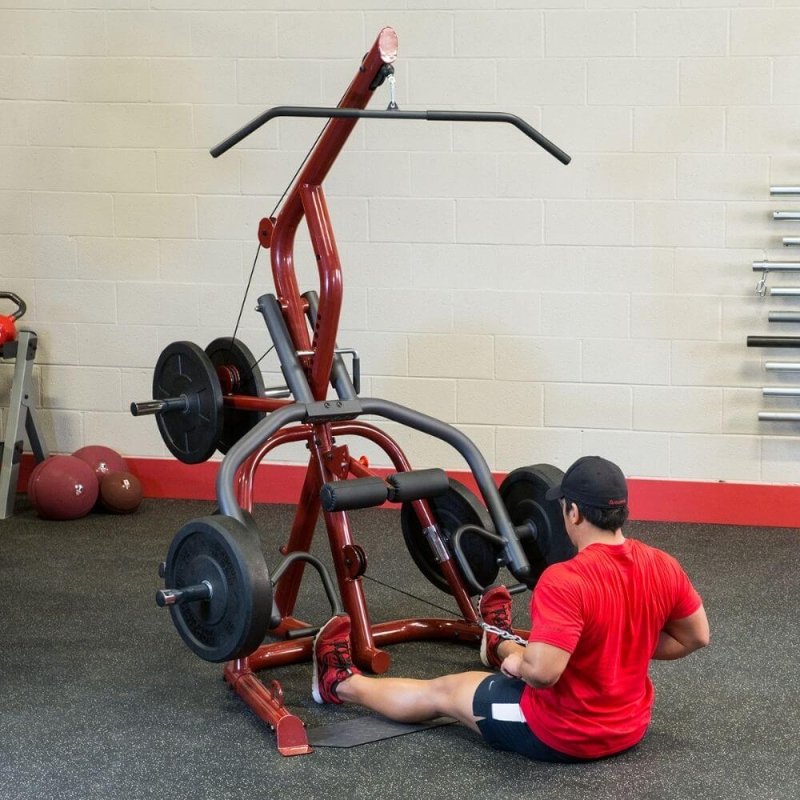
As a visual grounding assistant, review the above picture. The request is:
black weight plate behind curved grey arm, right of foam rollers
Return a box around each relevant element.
[400,478,500,594]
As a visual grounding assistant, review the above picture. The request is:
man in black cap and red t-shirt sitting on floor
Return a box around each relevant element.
[313,456,709,762]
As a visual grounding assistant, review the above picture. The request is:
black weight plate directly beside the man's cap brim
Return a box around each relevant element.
[500,464,575,579]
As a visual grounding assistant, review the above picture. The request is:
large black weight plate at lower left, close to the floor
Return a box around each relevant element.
[164,516,272,662]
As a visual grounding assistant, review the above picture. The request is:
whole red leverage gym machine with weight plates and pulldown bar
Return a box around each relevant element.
[136,28,572,755]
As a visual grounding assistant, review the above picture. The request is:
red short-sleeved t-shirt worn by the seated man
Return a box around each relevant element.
[521,539,702,758]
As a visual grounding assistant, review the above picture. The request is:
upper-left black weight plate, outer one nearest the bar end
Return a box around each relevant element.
[153,342,222,464]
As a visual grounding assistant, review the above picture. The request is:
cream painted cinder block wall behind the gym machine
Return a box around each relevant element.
[0,0,800,494]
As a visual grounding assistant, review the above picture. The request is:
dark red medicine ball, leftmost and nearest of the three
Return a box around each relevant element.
[28,456,99,519]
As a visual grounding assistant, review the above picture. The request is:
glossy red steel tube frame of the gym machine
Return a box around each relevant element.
[212,28,520,756]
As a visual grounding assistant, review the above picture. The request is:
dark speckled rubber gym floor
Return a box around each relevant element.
[0,497,800,800]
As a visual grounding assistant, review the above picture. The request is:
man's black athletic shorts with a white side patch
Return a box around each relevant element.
[472,672,592,764]
